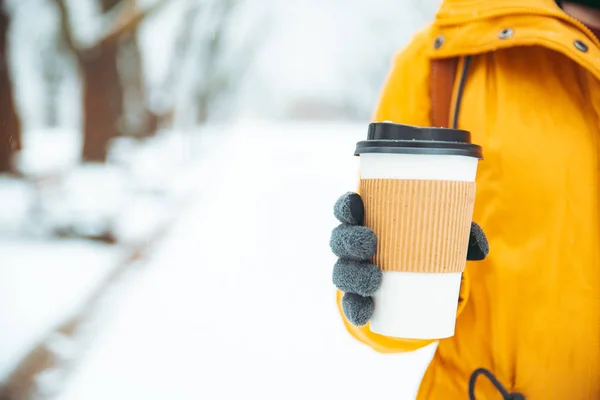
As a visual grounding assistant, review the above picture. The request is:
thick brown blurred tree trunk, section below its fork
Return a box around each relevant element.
[80,40,123,162]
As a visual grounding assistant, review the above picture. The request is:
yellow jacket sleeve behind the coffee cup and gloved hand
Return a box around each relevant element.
[337,30,469,353]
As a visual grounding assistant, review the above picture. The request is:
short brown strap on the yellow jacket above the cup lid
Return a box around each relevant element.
[429,58,458,128]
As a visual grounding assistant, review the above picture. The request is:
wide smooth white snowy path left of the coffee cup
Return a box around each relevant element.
[54,125,432,400]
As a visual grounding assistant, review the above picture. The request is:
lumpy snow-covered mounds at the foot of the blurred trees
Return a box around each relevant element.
[0,128,203,243]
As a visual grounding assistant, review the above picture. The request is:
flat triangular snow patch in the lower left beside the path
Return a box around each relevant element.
[0,239,122,381]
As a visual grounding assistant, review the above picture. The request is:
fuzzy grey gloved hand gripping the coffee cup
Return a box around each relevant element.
[330,192,489,326]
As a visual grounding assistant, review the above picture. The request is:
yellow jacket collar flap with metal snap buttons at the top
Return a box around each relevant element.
[427,0,600,63]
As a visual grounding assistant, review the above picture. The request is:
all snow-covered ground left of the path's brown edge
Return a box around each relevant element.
[0,126,221,388]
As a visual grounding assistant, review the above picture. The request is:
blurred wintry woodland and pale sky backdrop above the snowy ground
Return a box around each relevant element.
[0,0,439,171]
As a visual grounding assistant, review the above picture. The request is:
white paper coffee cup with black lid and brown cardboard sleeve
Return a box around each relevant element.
[355,122,482,339]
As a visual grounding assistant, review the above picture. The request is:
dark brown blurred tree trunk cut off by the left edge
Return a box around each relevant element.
[0,0,21,172]
